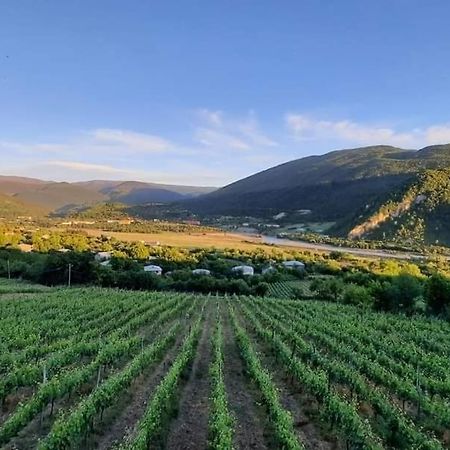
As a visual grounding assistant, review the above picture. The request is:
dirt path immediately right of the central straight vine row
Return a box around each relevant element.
[222,305,270,449]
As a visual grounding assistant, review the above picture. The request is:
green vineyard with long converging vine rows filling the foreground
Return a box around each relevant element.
[0,285,450,450]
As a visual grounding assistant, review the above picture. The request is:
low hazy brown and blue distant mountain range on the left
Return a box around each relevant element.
[0,176,214,213]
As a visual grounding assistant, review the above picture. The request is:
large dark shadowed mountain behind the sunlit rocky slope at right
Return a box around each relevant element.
[188,144,450,243]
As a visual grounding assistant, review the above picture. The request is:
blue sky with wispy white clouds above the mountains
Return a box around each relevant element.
[0,0,450,186]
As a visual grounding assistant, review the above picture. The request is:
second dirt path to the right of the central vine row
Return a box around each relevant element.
[237,306,345,450]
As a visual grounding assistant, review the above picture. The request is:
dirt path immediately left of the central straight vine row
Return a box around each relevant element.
[166,301,215,450]
